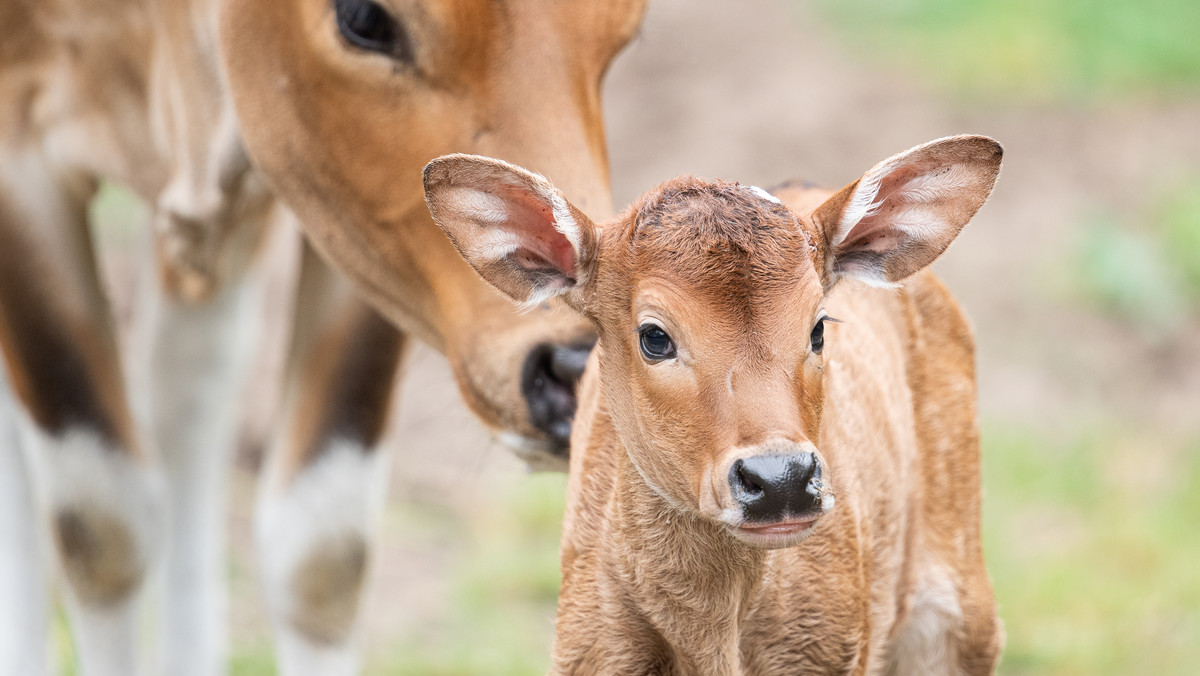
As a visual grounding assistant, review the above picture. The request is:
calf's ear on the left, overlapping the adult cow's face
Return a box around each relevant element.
[425,155,596,309]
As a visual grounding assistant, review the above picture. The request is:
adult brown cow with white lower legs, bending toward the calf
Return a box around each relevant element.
[0,0,643,676]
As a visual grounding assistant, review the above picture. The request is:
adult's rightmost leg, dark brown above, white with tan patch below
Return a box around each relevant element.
[257,240,407,676]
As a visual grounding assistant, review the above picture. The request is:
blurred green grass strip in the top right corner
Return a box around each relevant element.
[818,0,1200,101]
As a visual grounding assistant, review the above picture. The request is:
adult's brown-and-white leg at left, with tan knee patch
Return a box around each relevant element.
[0,149,162,676]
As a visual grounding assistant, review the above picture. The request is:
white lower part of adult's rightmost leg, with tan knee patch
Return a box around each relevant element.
[257,439,388,676]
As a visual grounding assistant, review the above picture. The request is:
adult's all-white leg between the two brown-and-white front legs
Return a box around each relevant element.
[136,223,274,676]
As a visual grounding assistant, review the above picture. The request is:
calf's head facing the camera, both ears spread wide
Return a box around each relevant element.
[425,136,1001,548]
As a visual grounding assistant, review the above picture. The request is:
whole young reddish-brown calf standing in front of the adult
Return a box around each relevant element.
[425,136,1002,675]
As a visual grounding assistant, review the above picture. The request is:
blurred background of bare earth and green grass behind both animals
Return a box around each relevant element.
[75,0,1200,676]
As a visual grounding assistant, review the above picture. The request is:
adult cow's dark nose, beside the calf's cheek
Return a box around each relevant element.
[521,342,594,455]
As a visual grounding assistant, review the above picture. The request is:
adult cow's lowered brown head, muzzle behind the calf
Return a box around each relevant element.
[220,0,644,465]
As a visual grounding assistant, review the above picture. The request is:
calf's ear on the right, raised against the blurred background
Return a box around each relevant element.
[812,136,1003,287]
